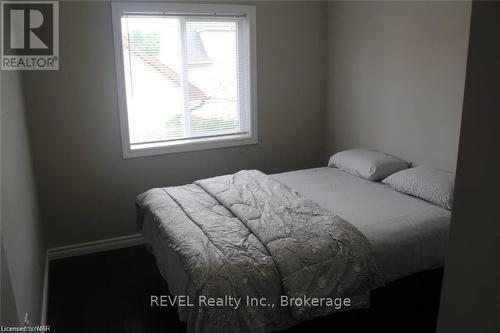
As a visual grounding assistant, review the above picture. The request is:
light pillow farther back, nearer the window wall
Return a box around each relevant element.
[328,149,408,180]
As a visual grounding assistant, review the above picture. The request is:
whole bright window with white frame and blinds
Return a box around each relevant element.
[113,3,257,157]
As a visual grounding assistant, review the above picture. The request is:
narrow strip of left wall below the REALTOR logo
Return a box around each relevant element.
[1,71,45,324]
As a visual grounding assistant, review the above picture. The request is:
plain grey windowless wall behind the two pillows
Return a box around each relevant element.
[326,1,471,170]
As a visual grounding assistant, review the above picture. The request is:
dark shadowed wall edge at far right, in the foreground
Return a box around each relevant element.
[437,1,500,333]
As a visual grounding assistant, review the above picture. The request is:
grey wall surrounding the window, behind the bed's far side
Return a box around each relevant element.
[24,1,326,247]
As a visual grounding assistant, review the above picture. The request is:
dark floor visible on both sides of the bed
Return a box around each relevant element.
[48,246,442,333]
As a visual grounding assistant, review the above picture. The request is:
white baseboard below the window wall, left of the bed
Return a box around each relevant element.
[47,234,144,260]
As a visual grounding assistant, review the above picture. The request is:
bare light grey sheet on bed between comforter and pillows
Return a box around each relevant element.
[272,167,450,282]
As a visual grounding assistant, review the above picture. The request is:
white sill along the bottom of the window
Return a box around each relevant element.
[123,135,258,158]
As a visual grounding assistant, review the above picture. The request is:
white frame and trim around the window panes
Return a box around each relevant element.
[111,2,258,158]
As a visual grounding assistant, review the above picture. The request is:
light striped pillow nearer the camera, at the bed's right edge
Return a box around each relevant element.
[382,167,455,210]
